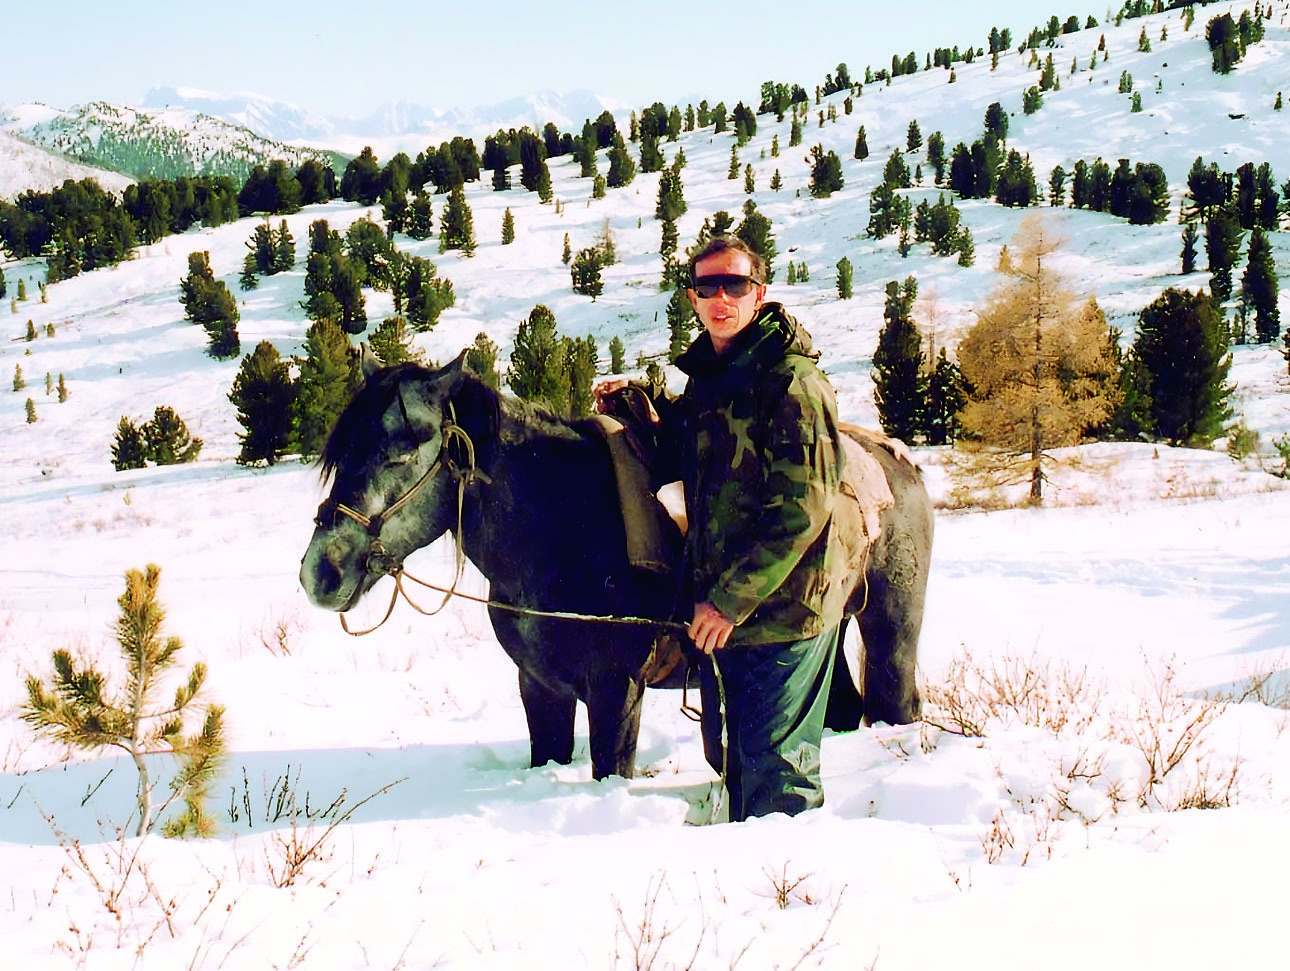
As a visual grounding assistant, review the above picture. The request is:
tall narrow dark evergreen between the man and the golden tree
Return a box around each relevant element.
[873,276,926,442]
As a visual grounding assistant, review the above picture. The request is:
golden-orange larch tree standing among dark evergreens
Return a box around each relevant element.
[958,214,1118,503]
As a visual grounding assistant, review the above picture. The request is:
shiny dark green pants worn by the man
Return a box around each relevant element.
[699,627,837,821]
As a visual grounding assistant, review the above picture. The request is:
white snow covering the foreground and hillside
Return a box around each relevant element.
[0,4,1290,971]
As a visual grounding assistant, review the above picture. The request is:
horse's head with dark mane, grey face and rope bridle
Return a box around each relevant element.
[301,352,497,611]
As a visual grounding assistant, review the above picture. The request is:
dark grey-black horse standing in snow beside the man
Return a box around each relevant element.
[301,352,931,779]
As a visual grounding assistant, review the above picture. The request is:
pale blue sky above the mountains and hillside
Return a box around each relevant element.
[0,0,1078,113]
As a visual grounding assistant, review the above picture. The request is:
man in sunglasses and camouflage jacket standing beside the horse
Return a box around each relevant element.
[597,236,846,820]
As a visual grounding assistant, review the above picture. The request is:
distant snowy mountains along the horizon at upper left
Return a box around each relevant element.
[0,88,630,197]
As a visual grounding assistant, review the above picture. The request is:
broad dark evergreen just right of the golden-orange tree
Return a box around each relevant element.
[1134,288,1232,447]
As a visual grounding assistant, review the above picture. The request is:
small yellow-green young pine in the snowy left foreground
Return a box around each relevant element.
[22,564,224,836]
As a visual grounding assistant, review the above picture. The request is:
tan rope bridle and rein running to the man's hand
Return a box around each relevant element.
[315,404,689,637]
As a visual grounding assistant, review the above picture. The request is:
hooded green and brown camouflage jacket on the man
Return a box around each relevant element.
[657,303,848,645]
